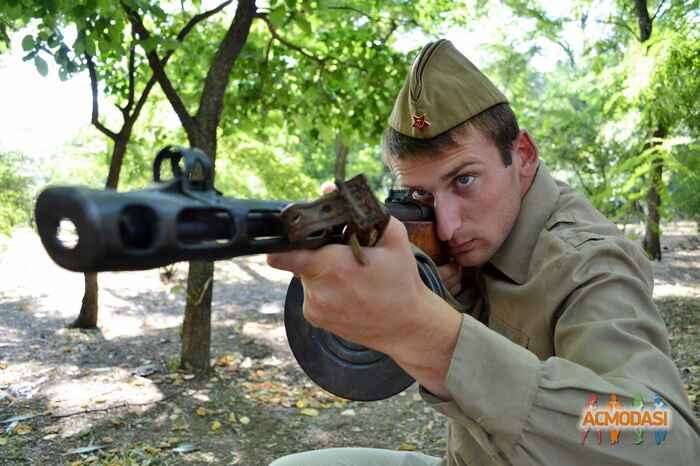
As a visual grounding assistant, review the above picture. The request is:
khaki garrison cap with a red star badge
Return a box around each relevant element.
[389,39,508,139]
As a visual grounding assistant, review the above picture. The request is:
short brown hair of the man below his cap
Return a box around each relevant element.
[382,103,520,167]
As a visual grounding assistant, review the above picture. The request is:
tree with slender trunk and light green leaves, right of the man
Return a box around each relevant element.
[486,0,698,260]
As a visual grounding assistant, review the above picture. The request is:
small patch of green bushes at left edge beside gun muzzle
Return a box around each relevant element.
[0,151,33,235]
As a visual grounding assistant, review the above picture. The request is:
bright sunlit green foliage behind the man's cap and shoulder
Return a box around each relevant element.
[487,0,700,219]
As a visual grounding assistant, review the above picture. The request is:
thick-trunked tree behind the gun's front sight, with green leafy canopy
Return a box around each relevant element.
[122,0,468,370]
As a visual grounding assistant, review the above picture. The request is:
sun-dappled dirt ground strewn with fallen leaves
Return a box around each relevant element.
[0,223,700,466]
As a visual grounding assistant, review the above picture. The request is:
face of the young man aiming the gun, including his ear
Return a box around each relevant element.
[392,128,537,267]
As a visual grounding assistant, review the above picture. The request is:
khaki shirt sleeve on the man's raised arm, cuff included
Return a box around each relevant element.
[421,244,700,465]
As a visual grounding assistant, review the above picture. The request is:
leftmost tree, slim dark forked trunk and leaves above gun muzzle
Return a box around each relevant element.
[0,2,230,328]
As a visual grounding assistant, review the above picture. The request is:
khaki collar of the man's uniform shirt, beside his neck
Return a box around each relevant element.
[489,162,559,284]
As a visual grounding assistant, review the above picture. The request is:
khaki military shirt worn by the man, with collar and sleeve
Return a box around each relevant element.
[421,164,700,466]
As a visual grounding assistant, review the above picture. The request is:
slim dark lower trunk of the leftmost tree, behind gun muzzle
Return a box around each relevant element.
[68,133,132,328]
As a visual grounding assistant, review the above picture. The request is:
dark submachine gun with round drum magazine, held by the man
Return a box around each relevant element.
[35,146,449,401]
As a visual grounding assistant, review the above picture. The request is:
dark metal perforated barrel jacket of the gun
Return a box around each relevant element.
[35,187,340,272]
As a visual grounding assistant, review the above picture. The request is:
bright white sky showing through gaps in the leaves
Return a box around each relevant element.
[0,1,597,162]
